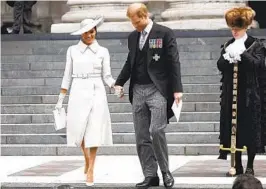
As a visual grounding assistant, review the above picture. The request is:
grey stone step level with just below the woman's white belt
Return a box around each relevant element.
[1,75,221,87]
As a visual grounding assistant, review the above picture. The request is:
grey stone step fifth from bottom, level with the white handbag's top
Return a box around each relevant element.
[1,102,220,114]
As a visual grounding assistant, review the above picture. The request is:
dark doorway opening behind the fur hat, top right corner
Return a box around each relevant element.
[248,1,266,28]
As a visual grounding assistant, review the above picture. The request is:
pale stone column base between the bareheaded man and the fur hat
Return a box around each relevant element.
[161,0,246,30]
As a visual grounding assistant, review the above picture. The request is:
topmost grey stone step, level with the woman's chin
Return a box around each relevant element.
[2,34,265,45]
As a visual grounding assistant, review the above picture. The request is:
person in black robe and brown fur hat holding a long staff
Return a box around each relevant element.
[217,7,266,176]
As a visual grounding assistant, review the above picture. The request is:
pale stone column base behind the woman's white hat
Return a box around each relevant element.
[51,0,147,33]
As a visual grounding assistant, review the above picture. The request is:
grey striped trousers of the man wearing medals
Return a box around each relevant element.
[132,84,169,177]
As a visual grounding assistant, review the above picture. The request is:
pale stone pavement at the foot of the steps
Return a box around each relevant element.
[0,156,266,189]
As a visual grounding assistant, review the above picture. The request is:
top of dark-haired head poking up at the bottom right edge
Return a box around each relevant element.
[232,174,263,189]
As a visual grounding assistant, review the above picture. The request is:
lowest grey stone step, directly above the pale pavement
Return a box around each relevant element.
[1,143,219,156]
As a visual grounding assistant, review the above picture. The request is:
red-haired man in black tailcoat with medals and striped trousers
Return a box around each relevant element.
[115,3,183,188]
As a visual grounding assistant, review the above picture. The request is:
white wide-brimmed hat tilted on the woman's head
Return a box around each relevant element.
[71,16,104,35]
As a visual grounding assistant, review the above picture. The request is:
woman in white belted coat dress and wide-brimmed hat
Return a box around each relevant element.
[56,18,115,185]
